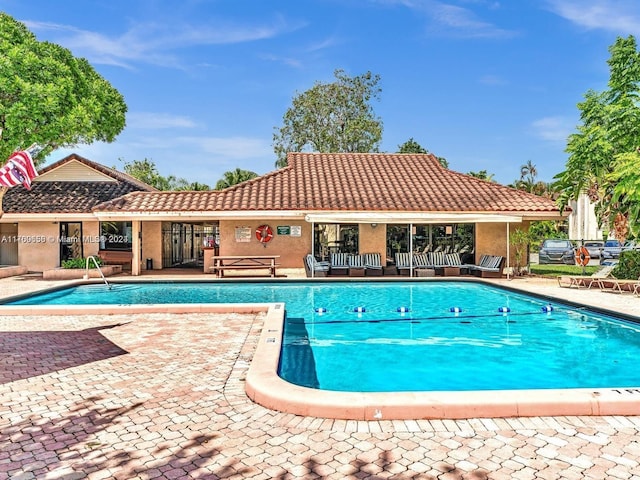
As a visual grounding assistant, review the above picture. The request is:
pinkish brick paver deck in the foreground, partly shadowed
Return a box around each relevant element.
[0,314,640,480]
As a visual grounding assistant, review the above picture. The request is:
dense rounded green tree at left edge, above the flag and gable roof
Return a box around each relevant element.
[0,12,127,164]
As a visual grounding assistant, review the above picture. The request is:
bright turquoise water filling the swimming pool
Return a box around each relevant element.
[7,282,640,392]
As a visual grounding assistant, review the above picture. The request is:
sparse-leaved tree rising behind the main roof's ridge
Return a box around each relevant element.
[273,70,382,168]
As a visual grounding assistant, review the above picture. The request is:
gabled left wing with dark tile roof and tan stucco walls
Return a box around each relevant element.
[0,154,157,272]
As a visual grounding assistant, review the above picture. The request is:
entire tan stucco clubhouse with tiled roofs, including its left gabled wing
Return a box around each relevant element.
[0,153,569,275]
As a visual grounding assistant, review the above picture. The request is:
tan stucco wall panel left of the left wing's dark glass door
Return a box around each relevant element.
[18,222,60,272]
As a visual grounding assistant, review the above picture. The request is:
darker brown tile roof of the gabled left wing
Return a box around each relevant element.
[2,154,157,214]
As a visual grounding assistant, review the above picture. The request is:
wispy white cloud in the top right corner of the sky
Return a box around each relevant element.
[547,0,640,35]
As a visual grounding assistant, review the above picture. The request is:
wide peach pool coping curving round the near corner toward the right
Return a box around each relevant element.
[245,304,640,420]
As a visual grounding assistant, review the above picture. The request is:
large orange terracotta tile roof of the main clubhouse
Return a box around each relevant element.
[94,153,558,214]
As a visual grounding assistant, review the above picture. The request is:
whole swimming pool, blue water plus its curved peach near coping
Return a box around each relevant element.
[7,281,640,418]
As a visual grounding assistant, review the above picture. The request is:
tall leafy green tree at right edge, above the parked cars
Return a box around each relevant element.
[555,36,640,240]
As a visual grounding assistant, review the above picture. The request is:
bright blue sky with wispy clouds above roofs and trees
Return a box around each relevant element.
[0,0,640,186]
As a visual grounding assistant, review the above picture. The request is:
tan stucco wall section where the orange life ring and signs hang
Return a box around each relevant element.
[220,219,311,268]
